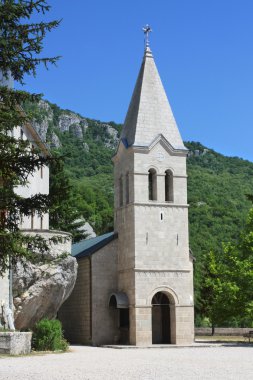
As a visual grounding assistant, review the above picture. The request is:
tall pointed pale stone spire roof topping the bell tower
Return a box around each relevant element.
[121,47,185,149]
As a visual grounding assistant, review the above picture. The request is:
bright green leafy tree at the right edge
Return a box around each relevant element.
[202,203,253,331]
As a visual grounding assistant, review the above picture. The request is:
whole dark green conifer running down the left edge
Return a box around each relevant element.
[0,0,59,273]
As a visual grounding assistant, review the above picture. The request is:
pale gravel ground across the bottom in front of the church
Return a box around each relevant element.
[0,346,253,380]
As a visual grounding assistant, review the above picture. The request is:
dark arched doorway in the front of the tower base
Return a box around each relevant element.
[152,292,171,344]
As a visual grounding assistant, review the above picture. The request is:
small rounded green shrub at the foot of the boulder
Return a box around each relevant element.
[32,319,68,351]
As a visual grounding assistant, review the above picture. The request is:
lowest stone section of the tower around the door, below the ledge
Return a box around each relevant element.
[130,305,194,346]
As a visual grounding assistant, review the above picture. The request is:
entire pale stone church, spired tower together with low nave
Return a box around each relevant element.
[58,34,194,346]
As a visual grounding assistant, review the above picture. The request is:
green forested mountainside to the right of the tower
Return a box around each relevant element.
[186,142,253,317]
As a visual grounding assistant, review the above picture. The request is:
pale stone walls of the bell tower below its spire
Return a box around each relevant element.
[114,142,194,345]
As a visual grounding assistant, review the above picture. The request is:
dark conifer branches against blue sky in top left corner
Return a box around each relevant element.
[0,0,60,83]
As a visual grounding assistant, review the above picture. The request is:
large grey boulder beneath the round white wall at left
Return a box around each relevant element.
[13,230,77,330]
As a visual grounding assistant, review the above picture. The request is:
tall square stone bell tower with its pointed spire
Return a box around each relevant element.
[113,29,194,345]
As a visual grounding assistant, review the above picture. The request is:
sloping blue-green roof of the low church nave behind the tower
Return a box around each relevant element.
[71,232,118,258]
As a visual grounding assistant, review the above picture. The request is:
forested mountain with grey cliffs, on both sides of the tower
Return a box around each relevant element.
[25,101,253,324]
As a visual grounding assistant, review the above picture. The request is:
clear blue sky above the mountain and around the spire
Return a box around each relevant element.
[17,0,253,161]
